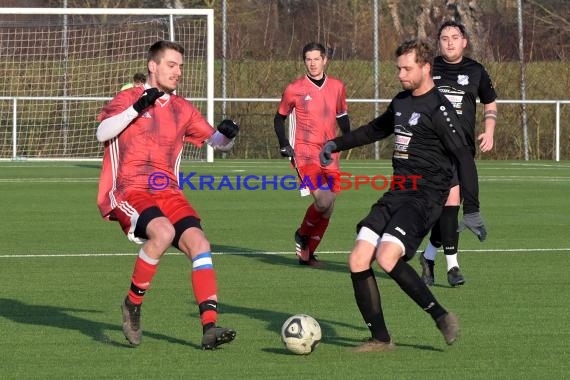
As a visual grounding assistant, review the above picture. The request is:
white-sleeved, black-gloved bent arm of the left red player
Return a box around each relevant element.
[95,88,164,142]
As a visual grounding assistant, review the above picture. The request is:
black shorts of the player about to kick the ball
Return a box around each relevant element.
[356,191,449,261]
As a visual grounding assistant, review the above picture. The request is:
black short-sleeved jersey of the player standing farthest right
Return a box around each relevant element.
[432,56,497,152]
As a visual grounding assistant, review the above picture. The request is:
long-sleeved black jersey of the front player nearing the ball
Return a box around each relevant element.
[333,87,479,213]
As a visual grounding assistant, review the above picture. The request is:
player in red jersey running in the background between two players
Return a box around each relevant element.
[274,42,350,267]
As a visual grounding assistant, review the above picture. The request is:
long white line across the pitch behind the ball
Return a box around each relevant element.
[0,247,570,259]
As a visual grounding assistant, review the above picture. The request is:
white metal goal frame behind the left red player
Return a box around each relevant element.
[0,8,214,162]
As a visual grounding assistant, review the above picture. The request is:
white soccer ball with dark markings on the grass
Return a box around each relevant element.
[281,314,321,355]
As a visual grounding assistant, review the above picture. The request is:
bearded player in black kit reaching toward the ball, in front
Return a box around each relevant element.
[320,40,479,352]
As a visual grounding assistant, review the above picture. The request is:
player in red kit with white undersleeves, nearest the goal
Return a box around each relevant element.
[97,41,239,350]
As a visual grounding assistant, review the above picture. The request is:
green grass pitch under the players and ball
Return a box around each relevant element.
[0,160,570,379]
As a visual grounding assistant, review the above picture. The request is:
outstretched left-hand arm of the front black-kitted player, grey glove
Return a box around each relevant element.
[320,107,394,166]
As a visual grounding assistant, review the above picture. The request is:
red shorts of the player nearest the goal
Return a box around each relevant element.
[110,190,200,243]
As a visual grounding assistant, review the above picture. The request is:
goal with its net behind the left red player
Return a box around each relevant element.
[0,8,213,161]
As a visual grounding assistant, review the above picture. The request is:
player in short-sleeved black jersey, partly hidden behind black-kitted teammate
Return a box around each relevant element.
[419,21,497,286]
